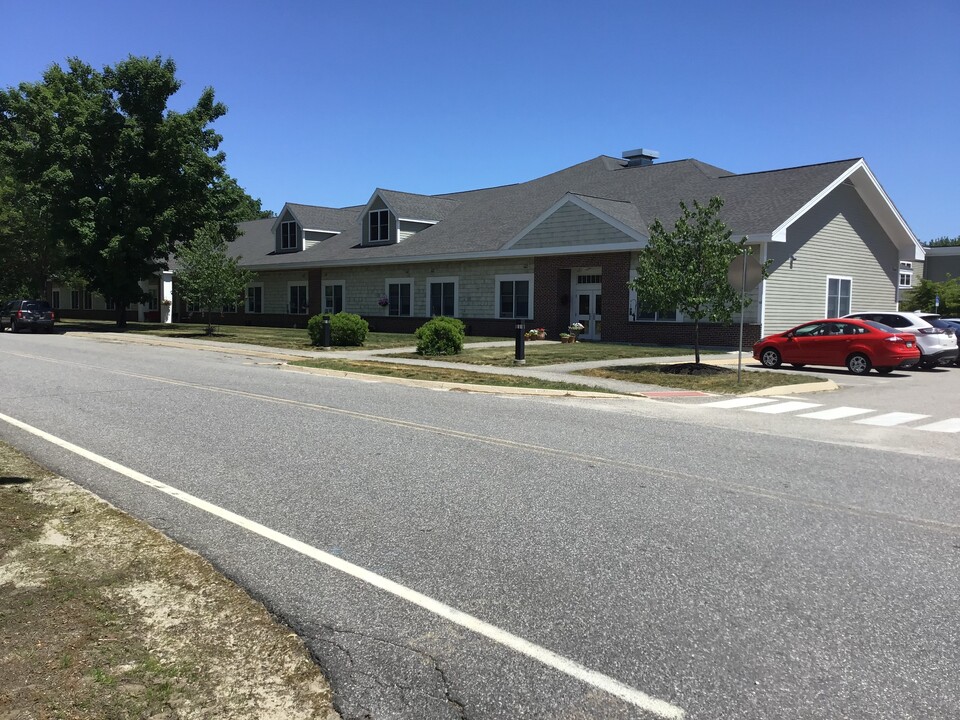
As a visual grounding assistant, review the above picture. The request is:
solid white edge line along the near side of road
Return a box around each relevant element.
[0,414,685,720]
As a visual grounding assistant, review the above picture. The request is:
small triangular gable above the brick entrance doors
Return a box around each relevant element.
[504,193,647,251]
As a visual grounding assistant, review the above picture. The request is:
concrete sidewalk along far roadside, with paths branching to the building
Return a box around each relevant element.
[71,332,837,397]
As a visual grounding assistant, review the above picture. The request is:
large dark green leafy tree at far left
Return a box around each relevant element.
[0,56,269,325]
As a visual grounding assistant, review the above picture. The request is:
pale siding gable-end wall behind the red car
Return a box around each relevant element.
[763,185,900,334]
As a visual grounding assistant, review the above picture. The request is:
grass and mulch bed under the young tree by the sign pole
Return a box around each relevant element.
[576,366,824,395]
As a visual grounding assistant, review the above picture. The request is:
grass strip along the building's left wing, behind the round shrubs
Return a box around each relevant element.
[59,320,503,350]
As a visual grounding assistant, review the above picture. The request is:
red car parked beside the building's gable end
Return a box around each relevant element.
[753,318,920,375]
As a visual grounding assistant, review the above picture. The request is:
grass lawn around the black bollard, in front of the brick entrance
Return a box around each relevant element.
[391,338,719,367]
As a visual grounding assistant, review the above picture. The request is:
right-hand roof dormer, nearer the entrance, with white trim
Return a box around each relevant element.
[360,188,460,246]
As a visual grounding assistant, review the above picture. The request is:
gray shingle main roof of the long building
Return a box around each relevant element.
[225,156,857,267]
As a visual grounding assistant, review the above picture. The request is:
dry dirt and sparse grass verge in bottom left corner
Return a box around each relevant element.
[0,443,339,720]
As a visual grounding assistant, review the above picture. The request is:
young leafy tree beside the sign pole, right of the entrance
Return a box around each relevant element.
[630,197,766,365]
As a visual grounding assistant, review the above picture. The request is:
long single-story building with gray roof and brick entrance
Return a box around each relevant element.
[50,149,924,345]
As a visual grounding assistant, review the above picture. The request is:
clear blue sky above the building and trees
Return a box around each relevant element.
[0,0,960,240]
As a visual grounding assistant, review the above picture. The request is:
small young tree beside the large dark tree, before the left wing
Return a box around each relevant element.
[174,224,253,335]
